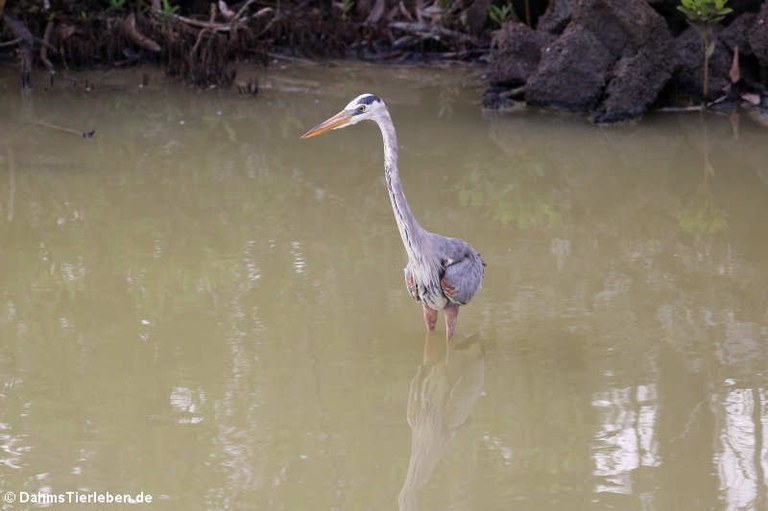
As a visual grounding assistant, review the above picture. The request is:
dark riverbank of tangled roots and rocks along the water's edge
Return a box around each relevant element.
[0,0,768,123]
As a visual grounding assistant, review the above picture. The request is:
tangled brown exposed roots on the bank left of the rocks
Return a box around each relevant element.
[0,0,490,88]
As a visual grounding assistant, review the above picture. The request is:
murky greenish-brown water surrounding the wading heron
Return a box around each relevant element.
[0,67,768,511]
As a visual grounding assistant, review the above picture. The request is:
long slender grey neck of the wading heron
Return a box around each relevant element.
[376,112,425,259]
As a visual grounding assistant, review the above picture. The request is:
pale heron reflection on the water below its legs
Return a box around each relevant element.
[398,335,485,511]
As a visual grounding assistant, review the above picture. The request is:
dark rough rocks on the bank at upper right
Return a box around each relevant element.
[484,0,768,123]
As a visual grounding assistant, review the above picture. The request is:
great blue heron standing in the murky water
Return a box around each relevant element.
[301,94,485,339]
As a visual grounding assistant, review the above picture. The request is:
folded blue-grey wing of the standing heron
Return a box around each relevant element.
[440,238,485,305]
